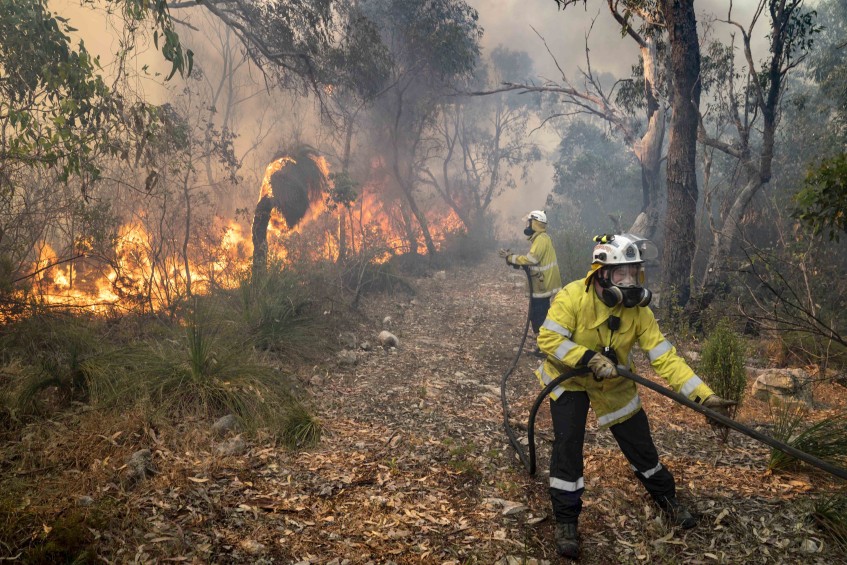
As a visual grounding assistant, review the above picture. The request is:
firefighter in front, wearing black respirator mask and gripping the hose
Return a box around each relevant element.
[536,234,734,559]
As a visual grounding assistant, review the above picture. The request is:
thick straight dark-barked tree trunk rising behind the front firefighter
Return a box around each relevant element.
[662,0,701,305]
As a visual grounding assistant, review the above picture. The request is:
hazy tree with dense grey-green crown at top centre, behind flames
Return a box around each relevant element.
[360,0,482,256]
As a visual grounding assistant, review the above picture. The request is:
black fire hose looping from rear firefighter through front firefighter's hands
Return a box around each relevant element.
[500,267,847,480]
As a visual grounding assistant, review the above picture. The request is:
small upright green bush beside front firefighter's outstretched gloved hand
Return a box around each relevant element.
[698,318,747,405]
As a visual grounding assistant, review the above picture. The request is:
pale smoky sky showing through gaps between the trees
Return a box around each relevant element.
[50,0,788,237]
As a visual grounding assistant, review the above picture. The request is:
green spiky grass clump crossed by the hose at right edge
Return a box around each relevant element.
[768,401,847,470]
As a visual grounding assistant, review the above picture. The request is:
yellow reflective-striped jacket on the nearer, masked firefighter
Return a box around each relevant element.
[535,279,714,428]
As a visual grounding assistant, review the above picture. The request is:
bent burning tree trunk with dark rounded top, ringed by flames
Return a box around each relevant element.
[252,146,328,275]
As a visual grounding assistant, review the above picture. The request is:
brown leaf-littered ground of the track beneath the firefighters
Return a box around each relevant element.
[0,255,847,565]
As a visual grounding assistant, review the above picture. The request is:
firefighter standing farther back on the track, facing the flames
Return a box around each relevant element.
[499,210,562,335]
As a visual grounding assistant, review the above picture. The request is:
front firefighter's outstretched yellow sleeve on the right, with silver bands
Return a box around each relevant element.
[638,308,715,402]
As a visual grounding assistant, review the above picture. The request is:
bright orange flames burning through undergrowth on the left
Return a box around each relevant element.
[19,157,468,312]
